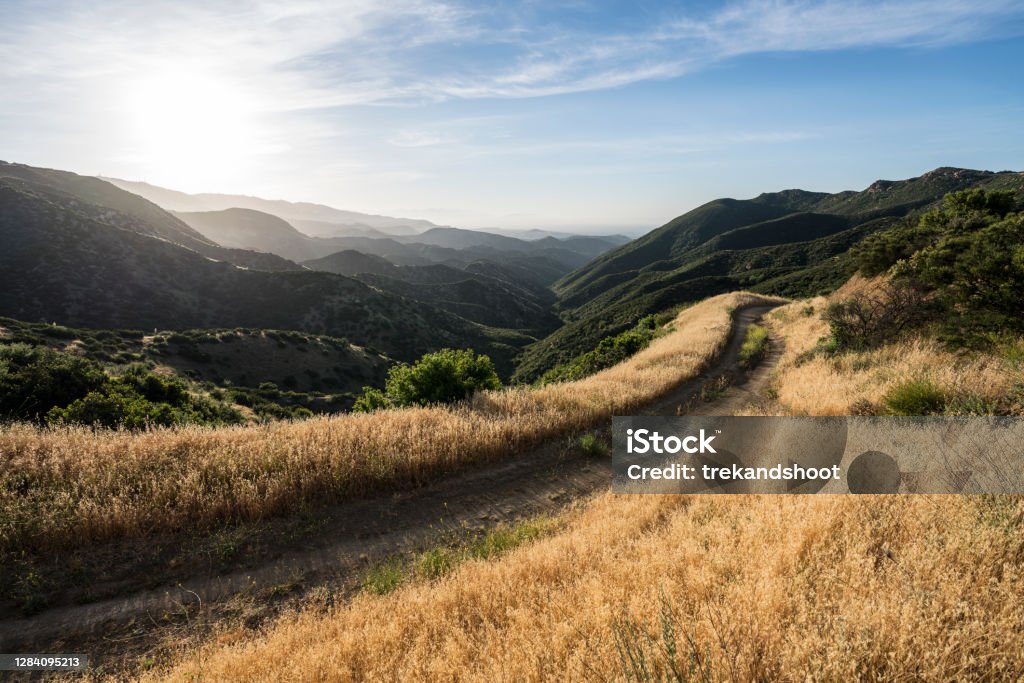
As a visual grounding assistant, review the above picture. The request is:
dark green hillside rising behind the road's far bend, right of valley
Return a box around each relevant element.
[516,168,1024,381]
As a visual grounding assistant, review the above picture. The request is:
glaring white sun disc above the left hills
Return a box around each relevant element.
[125,69,257,186]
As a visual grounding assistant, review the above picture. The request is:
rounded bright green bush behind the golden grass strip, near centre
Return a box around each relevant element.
[352,348,502,412]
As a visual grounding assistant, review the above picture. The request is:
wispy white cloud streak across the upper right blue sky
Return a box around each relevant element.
[415,0,1024,97]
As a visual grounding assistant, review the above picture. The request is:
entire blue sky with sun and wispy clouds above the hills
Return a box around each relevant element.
[0,0,1024,230]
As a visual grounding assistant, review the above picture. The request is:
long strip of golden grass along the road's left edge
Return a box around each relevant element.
[0,293,766,550]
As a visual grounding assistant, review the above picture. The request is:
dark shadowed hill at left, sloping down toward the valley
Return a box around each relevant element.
[0,165,528,373]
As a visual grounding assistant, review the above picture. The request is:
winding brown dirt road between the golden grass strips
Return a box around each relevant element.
[0,305,780,670]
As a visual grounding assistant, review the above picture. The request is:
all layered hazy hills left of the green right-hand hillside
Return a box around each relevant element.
[0,163,623,375]
